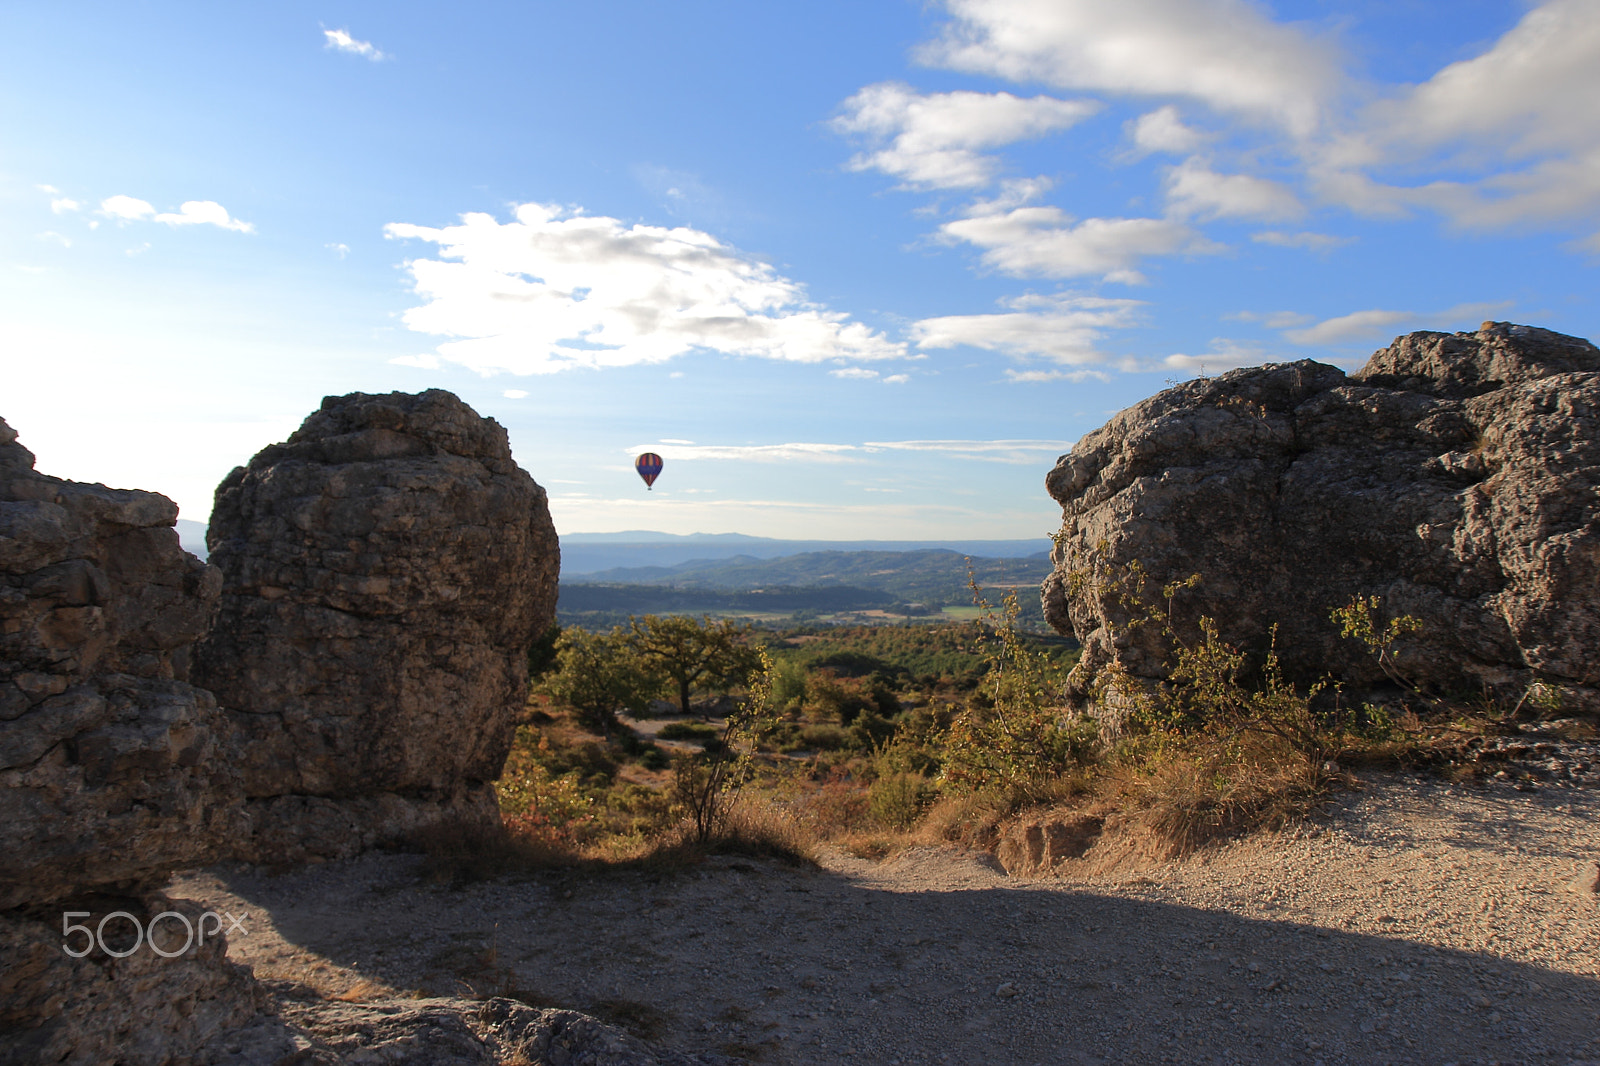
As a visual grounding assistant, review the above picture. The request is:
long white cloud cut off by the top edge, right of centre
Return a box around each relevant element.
[922,0,1338,136]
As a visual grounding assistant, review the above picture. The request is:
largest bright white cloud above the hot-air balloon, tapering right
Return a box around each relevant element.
[384,203,907,375]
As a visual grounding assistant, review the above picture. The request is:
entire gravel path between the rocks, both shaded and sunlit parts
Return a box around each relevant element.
[170,776,1600,1066]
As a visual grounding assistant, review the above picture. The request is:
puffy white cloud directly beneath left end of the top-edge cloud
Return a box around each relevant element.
[832,82,1099,189]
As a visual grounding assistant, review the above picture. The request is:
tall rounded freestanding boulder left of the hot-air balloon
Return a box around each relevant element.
[197,389,560,861]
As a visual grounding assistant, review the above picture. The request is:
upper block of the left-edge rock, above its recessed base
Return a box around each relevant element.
[0,421,242,911]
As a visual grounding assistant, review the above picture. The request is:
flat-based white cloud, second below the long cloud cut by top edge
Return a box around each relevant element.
[939,194,1222,283]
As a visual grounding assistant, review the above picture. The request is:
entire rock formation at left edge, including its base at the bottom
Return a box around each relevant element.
[0,421,266,1064]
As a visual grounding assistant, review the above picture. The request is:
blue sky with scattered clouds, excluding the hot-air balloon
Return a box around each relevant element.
[0,0,1600,539]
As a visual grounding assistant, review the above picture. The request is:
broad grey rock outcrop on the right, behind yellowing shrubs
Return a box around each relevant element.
[1043,323,1600,711]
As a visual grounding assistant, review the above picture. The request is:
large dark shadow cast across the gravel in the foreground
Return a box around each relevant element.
[189,852,1600,1066]
